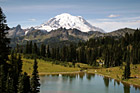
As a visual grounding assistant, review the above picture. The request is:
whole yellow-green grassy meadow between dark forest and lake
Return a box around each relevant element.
[22,58,140,87]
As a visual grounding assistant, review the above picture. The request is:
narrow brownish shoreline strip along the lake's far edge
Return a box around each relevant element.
[39,70,140,88]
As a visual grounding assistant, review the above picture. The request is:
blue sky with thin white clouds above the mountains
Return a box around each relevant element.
[0,0,140,32]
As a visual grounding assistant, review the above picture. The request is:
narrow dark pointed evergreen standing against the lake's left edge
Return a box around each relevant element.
[31,59,40,93]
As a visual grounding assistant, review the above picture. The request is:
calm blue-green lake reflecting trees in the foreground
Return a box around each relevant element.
[40,73,140,93]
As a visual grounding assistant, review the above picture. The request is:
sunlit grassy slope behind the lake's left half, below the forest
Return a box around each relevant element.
[22,58,89,74]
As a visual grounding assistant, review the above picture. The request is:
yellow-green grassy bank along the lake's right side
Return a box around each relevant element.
[88,64,140,87]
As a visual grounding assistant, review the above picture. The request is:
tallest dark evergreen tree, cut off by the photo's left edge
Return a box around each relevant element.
[0,7,10,93]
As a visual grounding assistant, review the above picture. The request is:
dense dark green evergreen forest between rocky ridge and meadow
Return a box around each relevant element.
[17,26,140,79]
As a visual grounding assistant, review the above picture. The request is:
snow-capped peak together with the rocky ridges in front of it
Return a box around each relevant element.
[8,14,135,46]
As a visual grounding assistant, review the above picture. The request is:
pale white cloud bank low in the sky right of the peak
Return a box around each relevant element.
[88,17,140,32]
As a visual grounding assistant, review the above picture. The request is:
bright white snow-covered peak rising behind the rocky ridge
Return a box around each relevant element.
[35,13,104,32]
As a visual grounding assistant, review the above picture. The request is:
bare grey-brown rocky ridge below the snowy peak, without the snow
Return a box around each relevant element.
[11,28,136,46]
